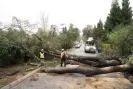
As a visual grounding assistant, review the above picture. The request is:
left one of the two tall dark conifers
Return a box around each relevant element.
[104,0,122,32]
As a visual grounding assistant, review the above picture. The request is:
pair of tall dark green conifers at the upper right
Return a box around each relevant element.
[104,0,133,33]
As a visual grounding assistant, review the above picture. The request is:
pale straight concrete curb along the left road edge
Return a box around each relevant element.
[1,67,41,89]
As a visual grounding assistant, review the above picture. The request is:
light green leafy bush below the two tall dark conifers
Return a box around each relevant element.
[109,26,133,56]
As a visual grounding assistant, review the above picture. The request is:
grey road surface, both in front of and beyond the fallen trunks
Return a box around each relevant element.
[5,44,133,89]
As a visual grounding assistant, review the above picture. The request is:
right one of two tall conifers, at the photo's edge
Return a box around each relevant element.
[122,0,133,25]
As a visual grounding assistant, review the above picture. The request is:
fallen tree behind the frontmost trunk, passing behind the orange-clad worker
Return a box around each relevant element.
[45,52,122,67]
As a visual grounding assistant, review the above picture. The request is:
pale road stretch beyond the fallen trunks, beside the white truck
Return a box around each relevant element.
[68,44,98,57]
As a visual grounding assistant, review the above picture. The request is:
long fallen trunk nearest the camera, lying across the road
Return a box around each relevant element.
[41,65,133,76]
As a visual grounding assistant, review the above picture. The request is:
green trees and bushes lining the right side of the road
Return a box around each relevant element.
[83,0,133,61]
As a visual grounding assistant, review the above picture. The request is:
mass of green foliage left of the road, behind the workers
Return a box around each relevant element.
[0,20,79,67]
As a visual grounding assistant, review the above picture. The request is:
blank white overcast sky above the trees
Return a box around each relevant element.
[0,0,133,29]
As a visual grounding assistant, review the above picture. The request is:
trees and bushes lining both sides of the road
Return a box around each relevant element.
[0,0,133,67]
